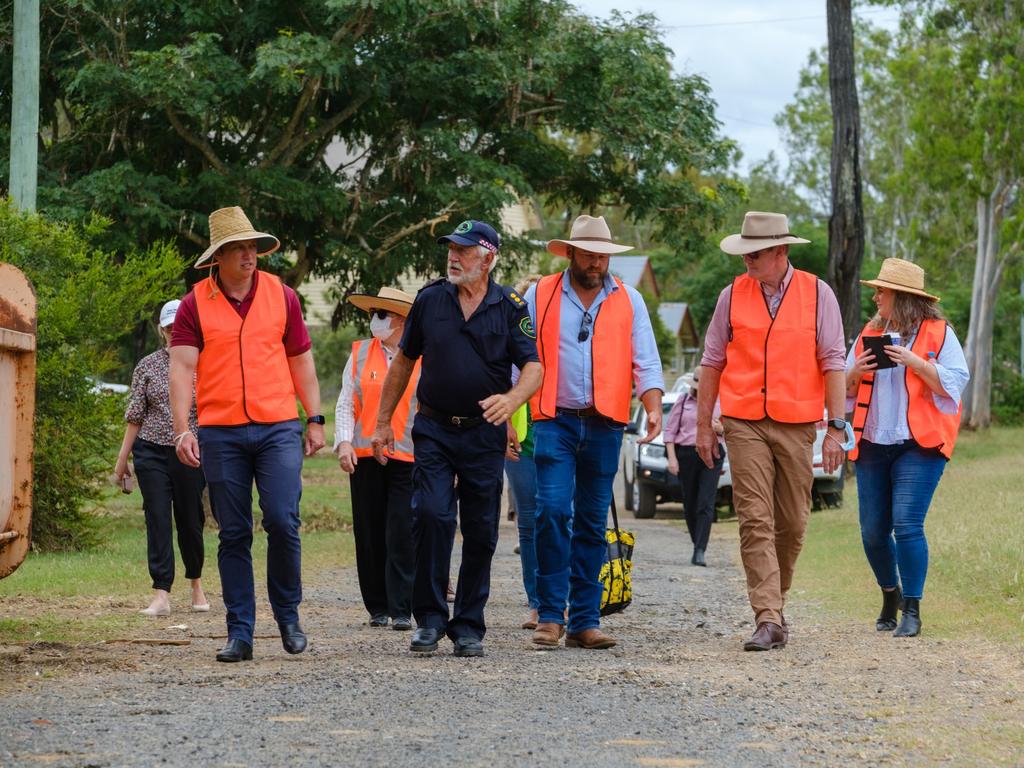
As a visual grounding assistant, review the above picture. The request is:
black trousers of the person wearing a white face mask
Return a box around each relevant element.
[350,457,416,618]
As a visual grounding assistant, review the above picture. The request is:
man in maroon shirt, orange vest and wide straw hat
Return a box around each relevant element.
[171,207,324,662]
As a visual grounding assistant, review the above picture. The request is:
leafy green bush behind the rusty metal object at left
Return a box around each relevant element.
[0,201,183,550]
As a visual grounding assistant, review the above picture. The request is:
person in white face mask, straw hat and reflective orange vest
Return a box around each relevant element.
[334,288,420,631]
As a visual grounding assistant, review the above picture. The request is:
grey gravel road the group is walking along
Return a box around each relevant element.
[0,505,1024,768]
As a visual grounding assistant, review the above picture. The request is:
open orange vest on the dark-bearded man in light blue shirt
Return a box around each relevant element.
[529,272,633,424]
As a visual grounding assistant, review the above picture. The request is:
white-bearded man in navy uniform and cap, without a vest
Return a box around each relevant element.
[373,220,542,656]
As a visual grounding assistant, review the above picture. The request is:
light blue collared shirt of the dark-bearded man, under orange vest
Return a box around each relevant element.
[524,269,665,408]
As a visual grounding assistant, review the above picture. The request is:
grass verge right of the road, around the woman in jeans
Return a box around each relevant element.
[794,428,1024,644]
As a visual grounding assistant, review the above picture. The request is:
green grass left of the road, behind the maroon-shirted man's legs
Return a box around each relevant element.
[0,436,354,644]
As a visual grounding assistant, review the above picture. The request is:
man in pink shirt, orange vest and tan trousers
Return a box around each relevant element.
[696,211,848,650]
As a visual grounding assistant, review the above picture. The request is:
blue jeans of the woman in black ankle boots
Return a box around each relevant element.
[857,440,946,600]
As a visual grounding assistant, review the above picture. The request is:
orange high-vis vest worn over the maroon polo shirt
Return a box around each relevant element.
[193,271,299,427]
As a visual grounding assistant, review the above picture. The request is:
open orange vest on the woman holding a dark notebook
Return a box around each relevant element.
[848,319,964,461]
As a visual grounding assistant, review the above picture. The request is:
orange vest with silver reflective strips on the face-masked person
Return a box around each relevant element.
[352,339,420,462]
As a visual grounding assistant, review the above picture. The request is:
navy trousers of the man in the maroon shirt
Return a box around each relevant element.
[199,419,302,645]
